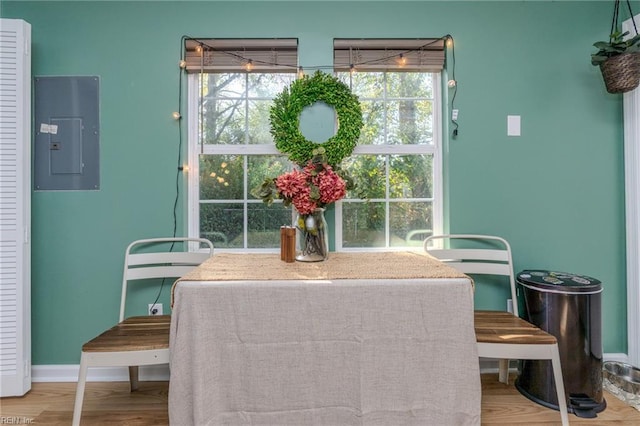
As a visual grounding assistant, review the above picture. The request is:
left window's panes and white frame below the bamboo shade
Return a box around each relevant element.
[185,72,296,249]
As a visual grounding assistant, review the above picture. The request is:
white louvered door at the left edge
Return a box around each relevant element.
[0,19,31,397]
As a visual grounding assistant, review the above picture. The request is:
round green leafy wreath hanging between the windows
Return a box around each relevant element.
[269,71,363,166]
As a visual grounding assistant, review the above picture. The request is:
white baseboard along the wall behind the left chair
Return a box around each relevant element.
[31,364,169,383]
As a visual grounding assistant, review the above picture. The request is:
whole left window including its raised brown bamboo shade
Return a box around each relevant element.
[186,39,297,250]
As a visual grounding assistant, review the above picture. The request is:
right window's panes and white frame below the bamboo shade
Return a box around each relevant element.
[337,71,441,248]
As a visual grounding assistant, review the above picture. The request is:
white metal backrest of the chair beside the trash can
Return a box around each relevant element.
[423,234,518,316]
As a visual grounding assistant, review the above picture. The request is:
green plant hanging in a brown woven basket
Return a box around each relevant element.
[591,0,640,93]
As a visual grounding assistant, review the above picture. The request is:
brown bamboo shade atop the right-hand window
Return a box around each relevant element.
[333,38,445,72]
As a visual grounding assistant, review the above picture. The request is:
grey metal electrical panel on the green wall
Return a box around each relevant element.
[33,76,100,191]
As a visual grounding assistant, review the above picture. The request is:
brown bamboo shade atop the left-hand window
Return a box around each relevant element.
[184,38,298,73]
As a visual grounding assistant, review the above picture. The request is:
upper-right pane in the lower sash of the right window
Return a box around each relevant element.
[389,155,433,198]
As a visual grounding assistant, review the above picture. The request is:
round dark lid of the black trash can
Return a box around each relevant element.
[516,269,601,293]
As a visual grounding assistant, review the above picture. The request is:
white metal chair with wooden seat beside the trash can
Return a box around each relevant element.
[424,235,569,425]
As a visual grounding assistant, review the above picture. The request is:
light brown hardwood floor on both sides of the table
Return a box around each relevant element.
[0,374,640,426]
